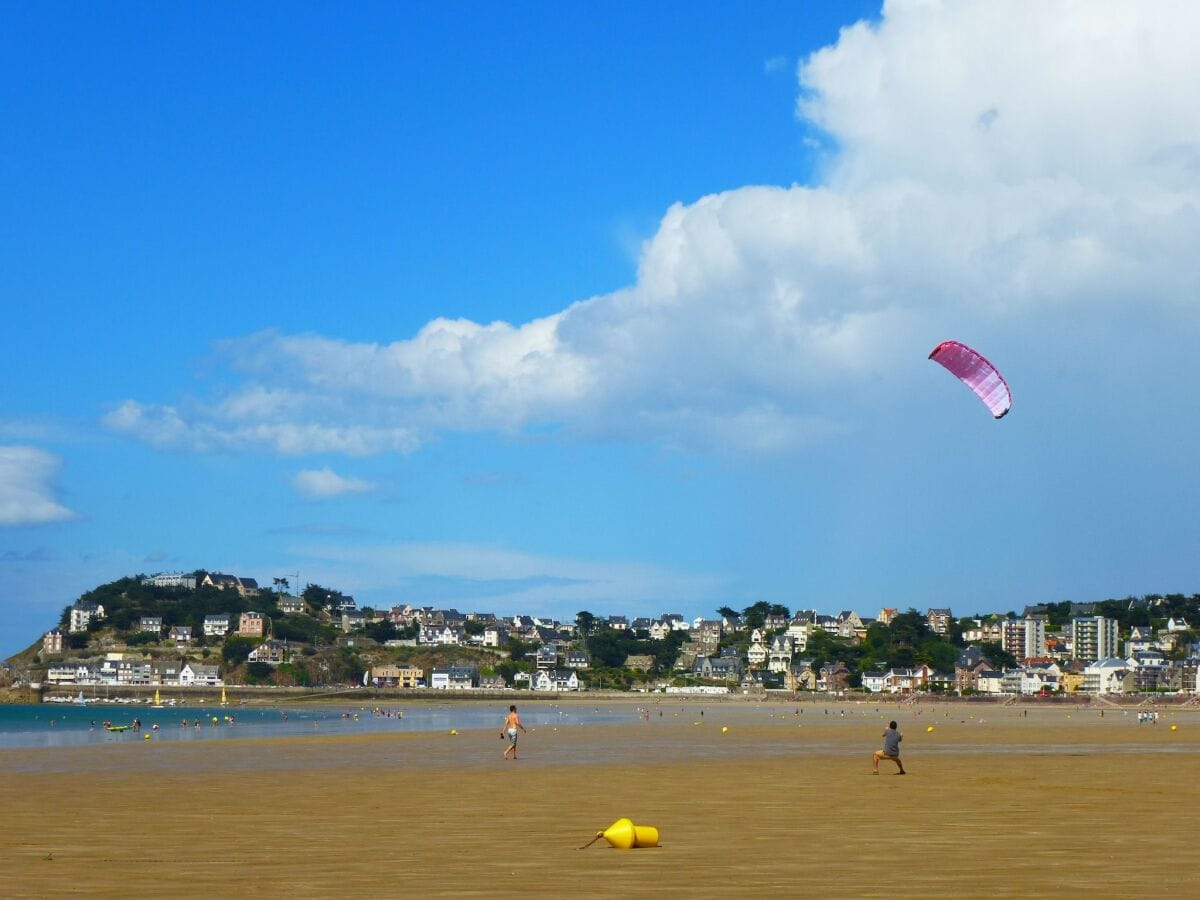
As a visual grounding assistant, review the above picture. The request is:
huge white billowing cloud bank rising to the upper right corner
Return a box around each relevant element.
[100,0,1200,455]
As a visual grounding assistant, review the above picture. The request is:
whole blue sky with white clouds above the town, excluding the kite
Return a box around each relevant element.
[0,0,1200,655]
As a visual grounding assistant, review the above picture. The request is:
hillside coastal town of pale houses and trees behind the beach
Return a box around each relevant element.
[14,570,1200,697]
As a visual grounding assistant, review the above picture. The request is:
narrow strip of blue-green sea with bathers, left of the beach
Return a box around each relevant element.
[0,701,634,749]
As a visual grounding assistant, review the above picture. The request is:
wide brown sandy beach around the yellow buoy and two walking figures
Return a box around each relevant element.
[0,701,1200,899]
